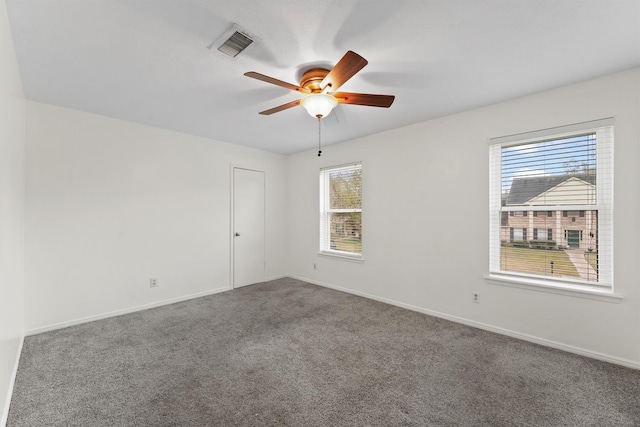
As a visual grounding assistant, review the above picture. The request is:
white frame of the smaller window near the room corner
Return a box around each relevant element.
[318,161,364,262]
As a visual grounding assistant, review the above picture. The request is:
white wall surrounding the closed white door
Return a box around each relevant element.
[25,101,286,333]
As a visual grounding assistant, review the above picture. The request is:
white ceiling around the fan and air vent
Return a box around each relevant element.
[6,0,640,154]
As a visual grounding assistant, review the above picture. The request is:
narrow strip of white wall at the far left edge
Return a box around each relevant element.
[0,1,25,425]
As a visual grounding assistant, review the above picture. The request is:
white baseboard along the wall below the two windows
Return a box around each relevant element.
[290,276,640,370]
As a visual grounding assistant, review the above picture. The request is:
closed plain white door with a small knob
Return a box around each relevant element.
[231,168,265,288]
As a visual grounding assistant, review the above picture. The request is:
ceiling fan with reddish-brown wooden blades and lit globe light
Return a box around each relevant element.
[244,51,395,119]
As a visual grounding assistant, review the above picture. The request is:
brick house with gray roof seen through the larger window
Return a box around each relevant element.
[501,173,598,251]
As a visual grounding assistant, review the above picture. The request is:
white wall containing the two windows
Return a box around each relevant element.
[287,69,640,368]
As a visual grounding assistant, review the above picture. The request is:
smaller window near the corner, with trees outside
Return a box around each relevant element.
[320,163,362,258]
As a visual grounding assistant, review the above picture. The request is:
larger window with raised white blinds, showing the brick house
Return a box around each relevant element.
[489,119,613,288]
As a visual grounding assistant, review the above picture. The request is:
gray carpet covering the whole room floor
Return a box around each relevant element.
[8,279,640,427]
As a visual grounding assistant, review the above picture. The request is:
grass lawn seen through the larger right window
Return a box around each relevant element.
[500,246,580,277]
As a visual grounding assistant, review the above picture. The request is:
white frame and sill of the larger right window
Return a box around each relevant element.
[485,118,620,296]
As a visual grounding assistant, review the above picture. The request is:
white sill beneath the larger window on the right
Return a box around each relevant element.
[484,273,624,304]
